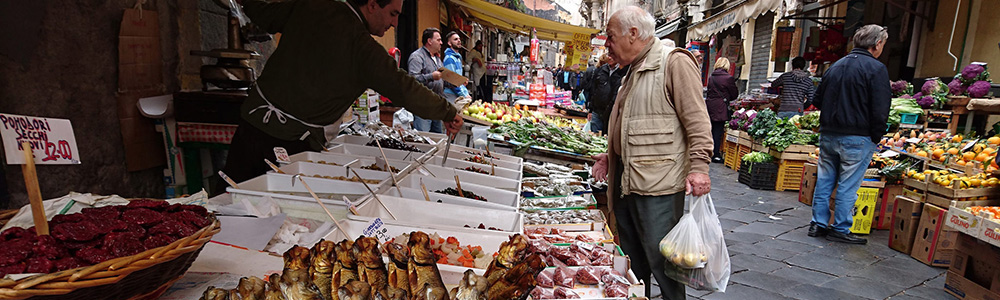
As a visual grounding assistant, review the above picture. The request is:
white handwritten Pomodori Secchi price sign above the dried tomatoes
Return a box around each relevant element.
[0,114,80,165]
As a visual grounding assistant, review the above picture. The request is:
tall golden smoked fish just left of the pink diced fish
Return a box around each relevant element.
[406,231,448,300]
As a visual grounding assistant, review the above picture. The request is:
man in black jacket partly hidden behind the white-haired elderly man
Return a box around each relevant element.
[585,55,628,132]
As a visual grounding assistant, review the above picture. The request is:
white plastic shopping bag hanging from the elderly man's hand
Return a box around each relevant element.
[660,194,731,292]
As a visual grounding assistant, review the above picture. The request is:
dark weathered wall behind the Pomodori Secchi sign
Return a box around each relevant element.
[0,0,176,207]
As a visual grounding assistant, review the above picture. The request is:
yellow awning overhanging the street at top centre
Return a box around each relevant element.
[451,0,600,42]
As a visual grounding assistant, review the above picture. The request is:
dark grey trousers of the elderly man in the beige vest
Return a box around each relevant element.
[611,163,687,300]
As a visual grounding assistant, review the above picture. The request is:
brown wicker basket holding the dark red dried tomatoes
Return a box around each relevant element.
[0,217,220,300]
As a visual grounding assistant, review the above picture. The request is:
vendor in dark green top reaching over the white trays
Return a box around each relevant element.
[225,0,462,182]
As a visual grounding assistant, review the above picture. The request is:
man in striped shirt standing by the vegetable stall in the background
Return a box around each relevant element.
[774,57,816,119]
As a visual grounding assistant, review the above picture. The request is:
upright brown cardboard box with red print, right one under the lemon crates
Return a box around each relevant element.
[910,203,959,267]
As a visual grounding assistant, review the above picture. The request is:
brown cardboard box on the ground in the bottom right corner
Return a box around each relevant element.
[944,234,1000,299]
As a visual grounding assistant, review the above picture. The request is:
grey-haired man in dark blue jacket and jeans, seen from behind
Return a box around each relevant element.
[809,25,892,244]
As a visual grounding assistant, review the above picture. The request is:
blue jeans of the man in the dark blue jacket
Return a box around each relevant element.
[812,133,875,234]
